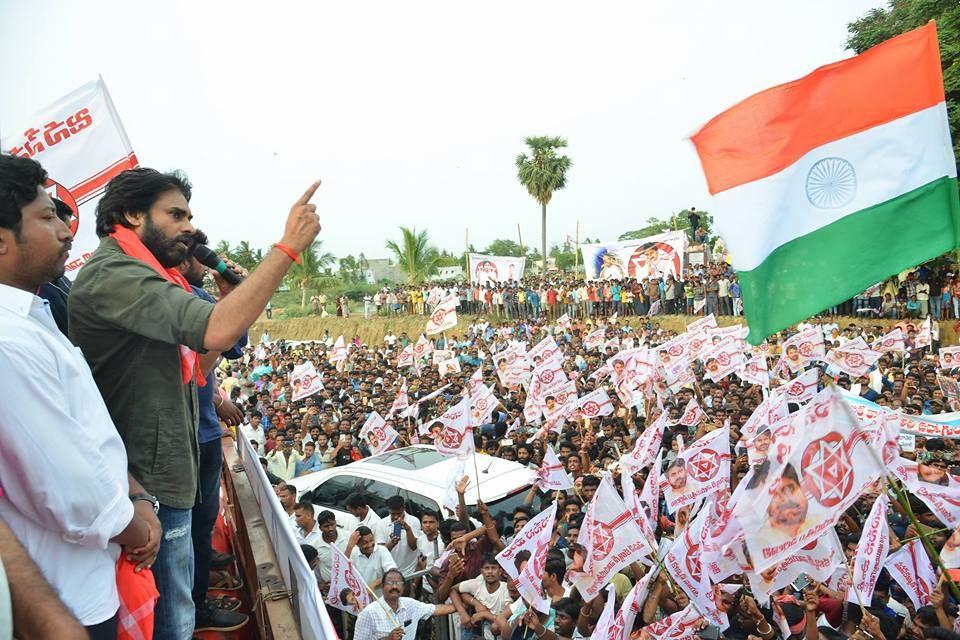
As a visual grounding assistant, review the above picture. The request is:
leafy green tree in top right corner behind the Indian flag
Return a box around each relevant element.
[847,0,960,165]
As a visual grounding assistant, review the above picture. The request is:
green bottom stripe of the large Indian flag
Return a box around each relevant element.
[737,177,960,344]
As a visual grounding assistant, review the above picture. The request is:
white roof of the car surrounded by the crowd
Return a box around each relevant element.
[289,445,531,504]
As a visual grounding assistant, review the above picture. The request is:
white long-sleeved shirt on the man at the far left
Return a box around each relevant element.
[0,285,133,625]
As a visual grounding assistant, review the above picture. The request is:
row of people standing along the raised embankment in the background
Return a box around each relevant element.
[311,259,960,320]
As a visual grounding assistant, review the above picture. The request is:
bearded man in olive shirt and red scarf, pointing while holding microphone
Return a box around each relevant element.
[69,168,320,640]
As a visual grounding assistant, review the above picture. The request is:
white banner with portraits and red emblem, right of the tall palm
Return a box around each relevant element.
[580,231,687,280]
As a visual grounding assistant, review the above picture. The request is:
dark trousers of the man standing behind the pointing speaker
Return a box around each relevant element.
[191,439,223,609]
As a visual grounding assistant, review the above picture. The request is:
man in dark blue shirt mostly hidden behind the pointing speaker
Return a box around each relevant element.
[180,234,248,631]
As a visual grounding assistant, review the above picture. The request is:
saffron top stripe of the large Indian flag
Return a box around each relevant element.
[691,22,943,194]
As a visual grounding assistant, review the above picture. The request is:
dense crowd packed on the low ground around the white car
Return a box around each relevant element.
[227,273,960,640]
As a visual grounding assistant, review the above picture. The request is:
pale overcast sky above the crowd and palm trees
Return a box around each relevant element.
[0,0,884,258]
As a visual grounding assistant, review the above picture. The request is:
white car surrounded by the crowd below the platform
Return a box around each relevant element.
[288,445,550,535]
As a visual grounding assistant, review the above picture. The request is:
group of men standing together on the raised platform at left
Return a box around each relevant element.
[0,155,320,640]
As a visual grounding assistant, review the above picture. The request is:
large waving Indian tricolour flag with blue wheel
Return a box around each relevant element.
[692,22,960,344]
